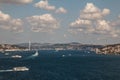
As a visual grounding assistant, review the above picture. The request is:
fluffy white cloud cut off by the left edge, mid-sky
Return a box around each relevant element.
[0,11,23,32]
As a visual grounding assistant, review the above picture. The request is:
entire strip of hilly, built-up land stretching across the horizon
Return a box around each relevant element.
[0,42,120,54]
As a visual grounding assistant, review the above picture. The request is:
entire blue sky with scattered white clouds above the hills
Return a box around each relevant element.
[0,0,120,44]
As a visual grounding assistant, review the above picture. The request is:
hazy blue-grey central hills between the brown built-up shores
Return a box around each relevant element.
[17,42,102,50]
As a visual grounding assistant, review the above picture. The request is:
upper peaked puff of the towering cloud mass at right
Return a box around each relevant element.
[80,3,110,20]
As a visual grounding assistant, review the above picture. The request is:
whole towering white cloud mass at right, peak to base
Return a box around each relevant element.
[70,3,119,37]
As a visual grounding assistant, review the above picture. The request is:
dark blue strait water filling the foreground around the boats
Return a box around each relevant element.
[0,51,120,80]
